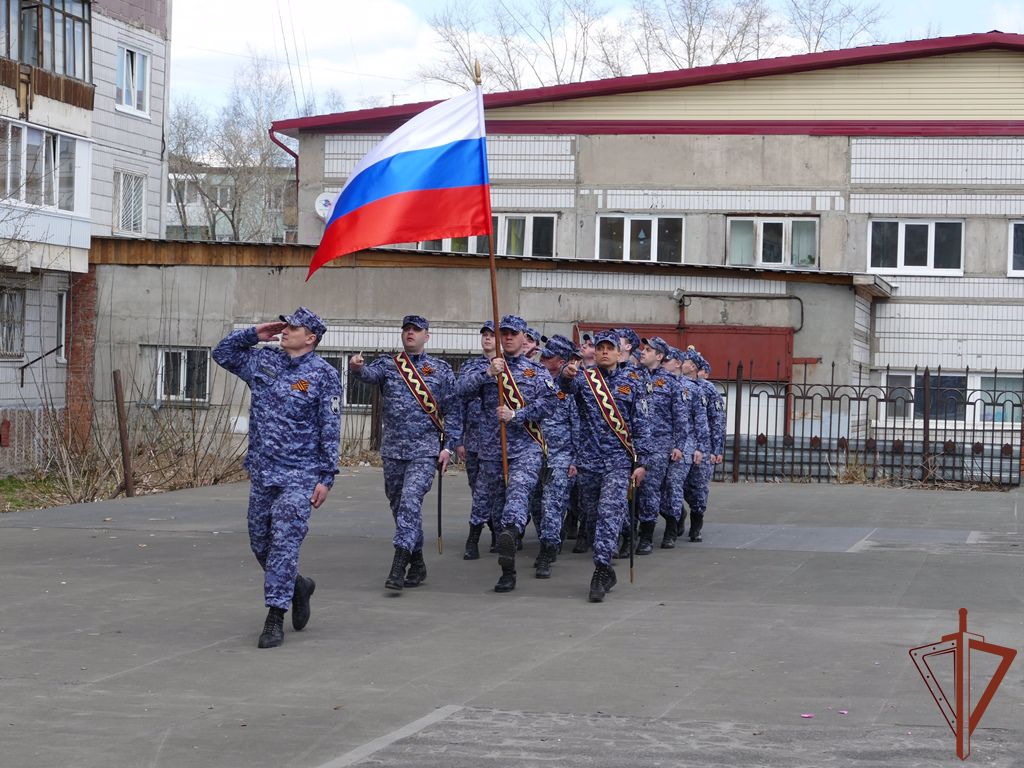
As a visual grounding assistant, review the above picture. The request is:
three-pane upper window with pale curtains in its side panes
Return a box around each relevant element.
[726,218,818,268]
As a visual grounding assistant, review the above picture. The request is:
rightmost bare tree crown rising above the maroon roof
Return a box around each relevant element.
[785,0,885,53]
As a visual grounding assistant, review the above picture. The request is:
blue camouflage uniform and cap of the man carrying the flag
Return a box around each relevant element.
[459,315,557,535]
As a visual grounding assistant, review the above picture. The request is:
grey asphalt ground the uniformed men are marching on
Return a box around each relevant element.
[0,468,1024,768]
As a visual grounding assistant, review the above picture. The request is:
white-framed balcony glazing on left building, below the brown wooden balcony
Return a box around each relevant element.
[0,120,77,211]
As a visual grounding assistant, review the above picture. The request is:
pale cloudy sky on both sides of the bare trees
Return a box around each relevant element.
[170,0,1024,118]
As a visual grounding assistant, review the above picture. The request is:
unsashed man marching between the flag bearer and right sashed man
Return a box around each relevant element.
[534,335,580,579]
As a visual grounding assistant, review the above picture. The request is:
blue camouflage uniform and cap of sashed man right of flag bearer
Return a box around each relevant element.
[558,331,651,567]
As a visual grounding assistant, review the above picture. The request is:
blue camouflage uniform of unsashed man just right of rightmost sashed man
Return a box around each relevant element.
[639,337,693,523]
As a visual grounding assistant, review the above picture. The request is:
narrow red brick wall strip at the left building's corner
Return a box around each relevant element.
[65,264,96,446]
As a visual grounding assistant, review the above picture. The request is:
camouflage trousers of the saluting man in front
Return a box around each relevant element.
[248,478,316,610]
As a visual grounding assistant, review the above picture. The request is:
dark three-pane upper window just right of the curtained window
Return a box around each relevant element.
[867,219,964,274]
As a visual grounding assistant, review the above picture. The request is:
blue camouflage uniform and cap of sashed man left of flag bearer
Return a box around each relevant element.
[353,315,462,553]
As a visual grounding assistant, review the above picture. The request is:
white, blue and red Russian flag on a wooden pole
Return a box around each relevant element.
[306,88,490,280]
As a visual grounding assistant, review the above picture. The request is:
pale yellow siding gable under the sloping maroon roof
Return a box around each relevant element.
[486,50,1024,121]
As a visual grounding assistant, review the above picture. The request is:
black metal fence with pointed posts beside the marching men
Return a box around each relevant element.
[716,364,1024,486]
